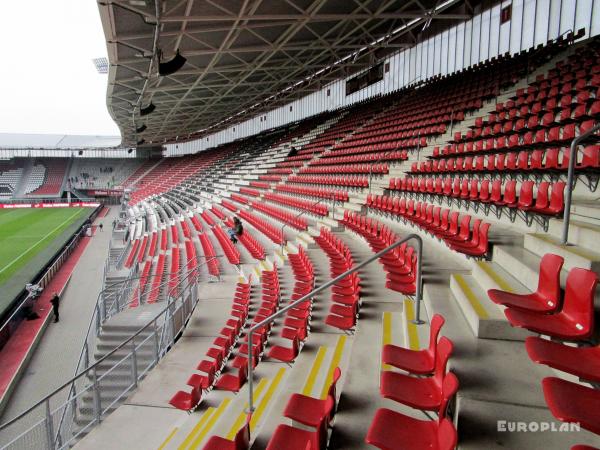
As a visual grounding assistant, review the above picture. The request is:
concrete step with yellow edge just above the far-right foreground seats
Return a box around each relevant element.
[525,234,600,273]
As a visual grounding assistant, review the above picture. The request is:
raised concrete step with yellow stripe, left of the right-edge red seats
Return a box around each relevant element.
[450,273,527,340]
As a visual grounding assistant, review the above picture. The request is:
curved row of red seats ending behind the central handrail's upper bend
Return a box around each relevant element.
[342,210,417,295]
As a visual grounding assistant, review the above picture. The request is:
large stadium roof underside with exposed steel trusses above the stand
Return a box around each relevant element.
[98,0,480,145]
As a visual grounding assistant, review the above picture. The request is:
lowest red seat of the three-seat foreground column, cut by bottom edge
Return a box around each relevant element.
[365,373,458,450]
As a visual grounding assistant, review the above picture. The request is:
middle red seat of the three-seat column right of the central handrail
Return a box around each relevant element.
[379,336,453,411]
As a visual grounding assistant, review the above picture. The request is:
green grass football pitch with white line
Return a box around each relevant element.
[0,208,93,314]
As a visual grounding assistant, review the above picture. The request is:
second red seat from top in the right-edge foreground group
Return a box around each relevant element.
[504,268,598,340]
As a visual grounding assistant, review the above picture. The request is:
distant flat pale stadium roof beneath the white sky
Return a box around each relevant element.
[0,133,121,150]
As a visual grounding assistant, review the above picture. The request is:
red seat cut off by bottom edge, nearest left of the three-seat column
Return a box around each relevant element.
[267,397,333,450]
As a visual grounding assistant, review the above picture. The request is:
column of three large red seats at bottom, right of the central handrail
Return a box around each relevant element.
[365,314,459,450]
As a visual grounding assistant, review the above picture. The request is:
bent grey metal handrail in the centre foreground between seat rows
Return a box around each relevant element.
[247,233,425,413]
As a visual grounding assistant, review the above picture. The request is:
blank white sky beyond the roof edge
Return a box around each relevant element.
[0,0,120,136]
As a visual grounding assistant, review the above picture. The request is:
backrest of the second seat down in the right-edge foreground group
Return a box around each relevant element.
[562,267,598,338]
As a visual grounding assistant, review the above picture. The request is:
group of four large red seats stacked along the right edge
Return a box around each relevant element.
[488,253,600,440]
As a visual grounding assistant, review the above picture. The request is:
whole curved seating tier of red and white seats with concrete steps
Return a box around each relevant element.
[0,8,600,450]
